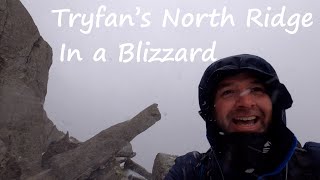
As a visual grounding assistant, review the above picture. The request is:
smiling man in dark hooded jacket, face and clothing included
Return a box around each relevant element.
[165,54,320,180]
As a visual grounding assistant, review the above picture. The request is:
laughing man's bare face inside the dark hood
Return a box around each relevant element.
[213,73,272,133]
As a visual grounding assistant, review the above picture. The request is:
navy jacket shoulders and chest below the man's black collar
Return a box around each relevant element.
[165,142,320,180]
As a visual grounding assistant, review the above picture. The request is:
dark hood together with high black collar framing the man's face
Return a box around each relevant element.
[199,54,297,179]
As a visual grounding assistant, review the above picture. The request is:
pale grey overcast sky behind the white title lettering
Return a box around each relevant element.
[22,0,320,170]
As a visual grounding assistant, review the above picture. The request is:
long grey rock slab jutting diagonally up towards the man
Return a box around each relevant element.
[36,104,161,179]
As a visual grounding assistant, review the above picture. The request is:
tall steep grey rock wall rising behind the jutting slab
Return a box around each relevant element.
[0,0,63,178]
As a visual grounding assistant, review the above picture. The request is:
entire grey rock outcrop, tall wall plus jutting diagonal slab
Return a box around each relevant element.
[0,0,172,180]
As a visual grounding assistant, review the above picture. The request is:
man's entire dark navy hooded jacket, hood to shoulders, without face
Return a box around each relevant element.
[165,54,320,180]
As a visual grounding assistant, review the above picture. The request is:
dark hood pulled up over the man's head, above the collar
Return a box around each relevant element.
[199,54,293,146]
